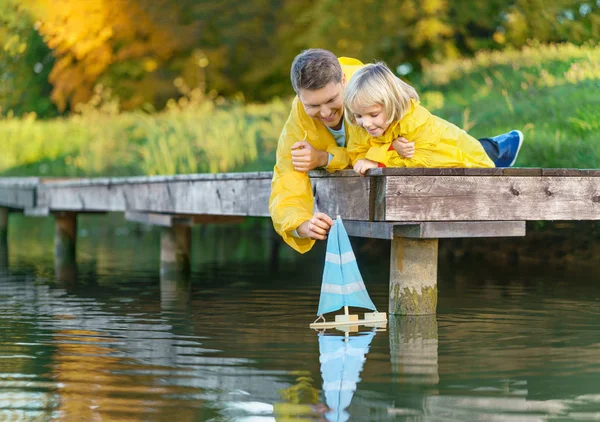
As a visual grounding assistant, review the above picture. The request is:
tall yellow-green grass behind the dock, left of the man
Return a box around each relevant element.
[0,89,289,177]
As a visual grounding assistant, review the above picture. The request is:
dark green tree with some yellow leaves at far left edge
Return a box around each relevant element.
[0,0,56,116]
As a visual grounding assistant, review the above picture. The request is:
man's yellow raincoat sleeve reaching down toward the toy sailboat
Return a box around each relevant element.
[269,102,318,253]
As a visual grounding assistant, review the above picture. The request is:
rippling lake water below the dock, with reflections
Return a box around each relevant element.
[0,216,600,422]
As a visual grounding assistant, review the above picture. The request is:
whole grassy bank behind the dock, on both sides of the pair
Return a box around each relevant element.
[0,44,600,177]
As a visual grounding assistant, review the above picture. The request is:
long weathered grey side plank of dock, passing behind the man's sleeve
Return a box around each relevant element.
[38,171,370,220]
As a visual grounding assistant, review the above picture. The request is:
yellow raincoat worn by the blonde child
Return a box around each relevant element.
[346,100,494,168]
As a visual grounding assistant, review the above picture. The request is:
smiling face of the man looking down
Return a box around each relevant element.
[298,79,346,130]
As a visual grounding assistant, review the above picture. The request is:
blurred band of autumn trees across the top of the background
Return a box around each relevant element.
[0,0,600,116]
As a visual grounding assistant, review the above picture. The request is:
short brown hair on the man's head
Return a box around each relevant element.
[290,48,344,94]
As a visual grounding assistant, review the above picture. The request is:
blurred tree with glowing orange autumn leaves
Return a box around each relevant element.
[26,0,197,111]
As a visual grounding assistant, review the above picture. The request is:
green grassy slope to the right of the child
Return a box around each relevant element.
[413,43,600,168]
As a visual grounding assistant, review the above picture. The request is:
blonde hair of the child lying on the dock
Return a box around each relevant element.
[344,62,419,125]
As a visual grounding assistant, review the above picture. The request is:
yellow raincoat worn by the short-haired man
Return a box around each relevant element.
[269,57,363,253]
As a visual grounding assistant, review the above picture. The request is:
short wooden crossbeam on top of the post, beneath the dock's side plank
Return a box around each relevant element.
[344,220,525,240]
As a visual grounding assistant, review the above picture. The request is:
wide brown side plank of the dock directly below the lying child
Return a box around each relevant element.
[375,176,600,221]
